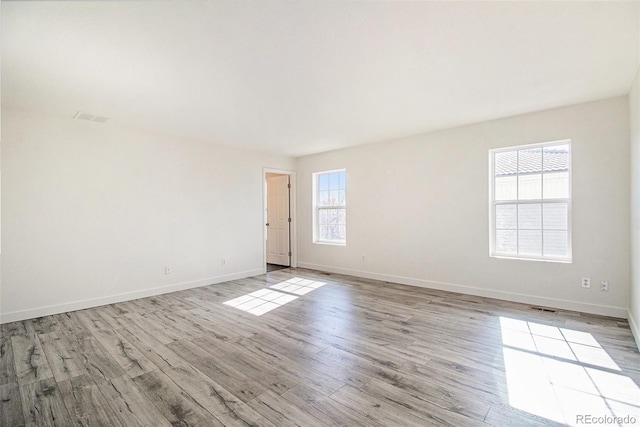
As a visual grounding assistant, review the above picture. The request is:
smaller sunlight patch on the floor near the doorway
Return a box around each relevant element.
[223,277,325,316]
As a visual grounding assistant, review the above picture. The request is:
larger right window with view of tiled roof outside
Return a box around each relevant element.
[489,141,571,262]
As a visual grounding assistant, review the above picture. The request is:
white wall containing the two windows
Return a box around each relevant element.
[297,97,629,317]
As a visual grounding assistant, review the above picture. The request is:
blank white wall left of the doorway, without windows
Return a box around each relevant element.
[0,110,294,322]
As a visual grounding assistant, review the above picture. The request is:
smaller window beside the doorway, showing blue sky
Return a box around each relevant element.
[313,169,347,245]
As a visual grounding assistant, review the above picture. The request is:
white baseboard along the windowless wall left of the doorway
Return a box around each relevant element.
[0,268,264,324]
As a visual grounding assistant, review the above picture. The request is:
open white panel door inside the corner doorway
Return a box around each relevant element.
[267,175,290,266]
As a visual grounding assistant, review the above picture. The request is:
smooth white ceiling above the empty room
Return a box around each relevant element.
[2,1,640,156]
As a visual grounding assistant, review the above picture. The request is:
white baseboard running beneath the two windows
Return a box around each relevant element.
[298,262,628,319]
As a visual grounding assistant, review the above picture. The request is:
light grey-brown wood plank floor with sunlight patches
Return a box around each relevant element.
[0,269,640,426]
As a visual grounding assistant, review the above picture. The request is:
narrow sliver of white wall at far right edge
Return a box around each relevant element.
[629,68,640,349]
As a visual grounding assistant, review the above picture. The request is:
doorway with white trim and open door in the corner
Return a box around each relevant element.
[263,169,295,272]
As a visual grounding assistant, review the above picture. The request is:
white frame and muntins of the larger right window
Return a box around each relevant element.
[489,139,573,263]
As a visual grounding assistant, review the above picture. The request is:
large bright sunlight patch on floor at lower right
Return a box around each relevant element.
[500,317,640,425]
